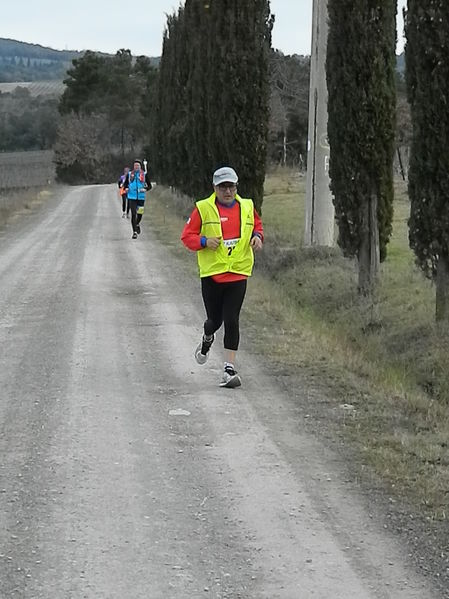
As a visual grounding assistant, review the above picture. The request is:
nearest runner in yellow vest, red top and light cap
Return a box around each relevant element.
[181,167,263,388]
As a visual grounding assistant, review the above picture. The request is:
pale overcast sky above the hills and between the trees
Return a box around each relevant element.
[0,0,406,56]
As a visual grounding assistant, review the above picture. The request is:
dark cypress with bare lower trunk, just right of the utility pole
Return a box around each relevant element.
[326,0,396,295]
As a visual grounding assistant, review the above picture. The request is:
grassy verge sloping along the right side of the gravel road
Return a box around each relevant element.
[151,175,449,522]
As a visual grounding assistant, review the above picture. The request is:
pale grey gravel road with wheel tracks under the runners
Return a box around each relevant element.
[0,186,437,599]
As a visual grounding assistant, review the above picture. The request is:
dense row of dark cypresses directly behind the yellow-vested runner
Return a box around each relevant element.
[151,0,273,210]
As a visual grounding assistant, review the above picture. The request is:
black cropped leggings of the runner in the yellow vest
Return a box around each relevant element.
[201,277,247,351]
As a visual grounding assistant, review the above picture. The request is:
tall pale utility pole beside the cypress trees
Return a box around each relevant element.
[304,0,334,246]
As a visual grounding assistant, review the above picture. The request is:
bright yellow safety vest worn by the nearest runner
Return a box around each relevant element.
[196,192,254,278]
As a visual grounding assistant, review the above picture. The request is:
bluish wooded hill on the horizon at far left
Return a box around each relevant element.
[0,38,159,82]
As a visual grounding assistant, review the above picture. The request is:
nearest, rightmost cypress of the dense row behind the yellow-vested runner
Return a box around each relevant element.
[208,0,273,211]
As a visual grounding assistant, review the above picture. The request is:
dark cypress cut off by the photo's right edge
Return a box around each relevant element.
[405,0,449,322]
